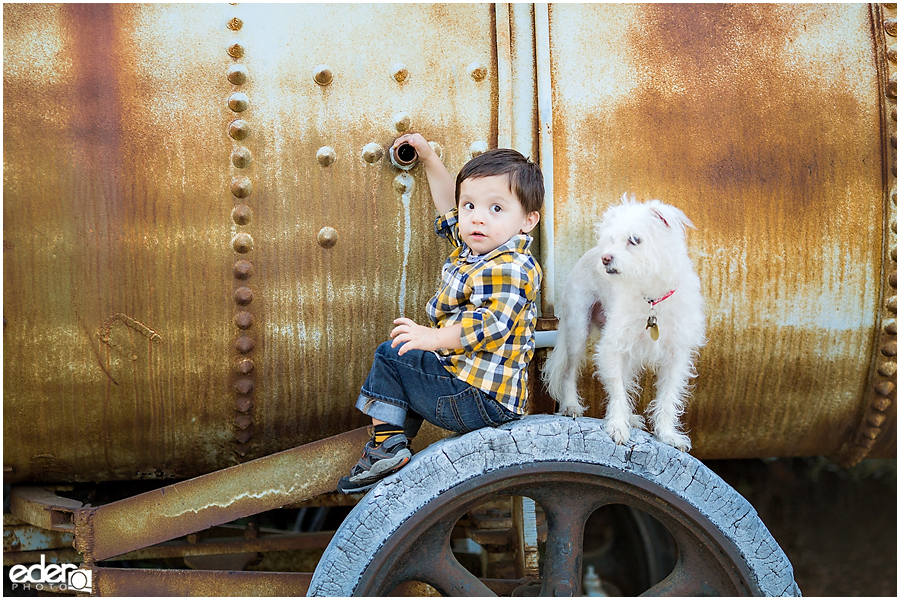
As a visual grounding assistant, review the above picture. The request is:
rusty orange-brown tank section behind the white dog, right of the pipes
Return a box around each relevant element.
[550,4,896,458]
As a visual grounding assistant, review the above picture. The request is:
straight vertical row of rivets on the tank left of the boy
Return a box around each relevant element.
[226,10,256,458]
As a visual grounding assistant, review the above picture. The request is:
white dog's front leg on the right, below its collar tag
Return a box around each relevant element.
[647,352,695,452]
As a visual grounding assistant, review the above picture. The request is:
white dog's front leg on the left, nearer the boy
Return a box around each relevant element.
[594,339,641,444]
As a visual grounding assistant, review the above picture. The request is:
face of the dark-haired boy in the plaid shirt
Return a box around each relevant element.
[459,175,540,254]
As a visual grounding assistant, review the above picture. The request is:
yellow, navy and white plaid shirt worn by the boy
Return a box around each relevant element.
[426,208,542,415]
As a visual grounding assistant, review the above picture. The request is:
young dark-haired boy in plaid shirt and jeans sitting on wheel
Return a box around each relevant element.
[338,134,544,494]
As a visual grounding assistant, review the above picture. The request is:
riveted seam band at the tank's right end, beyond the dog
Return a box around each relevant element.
[839,4,897,467]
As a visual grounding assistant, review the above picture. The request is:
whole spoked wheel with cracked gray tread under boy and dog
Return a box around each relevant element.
[309,415,800,596]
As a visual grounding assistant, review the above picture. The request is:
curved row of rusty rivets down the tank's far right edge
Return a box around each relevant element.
[841,4,897,467]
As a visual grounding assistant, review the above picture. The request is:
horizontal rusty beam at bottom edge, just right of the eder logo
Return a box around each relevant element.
[92,567,312,597]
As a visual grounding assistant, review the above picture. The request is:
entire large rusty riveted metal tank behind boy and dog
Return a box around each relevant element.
[3,4,896,483]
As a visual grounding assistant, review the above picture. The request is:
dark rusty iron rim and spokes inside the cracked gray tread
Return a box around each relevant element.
[354,461,761,596]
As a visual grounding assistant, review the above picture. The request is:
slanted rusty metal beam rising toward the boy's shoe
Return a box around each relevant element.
[75,428,369,561]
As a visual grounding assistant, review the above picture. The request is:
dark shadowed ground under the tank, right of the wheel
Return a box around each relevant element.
[706,458,897,597]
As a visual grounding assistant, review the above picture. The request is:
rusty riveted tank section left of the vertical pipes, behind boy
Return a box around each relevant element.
[3,4,497,482]
